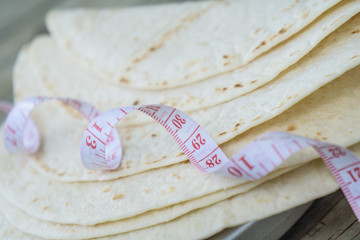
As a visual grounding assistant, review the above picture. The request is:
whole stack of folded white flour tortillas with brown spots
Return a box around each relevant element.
[0,0,360,239]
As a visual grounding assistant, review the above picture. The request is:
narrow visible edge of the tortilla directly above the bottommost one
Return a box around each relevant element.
[0,162,298,239]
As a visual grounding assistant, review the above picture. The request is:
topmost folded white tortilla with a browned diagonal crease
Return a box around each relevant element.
[47,0,339,89]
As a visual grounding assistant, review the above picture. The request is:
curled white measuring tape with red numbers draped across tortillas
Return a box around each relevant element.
[0,97,360,221]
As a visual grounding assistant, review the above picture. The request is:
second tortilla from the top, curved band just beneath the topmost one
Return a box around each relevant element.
[21,1,360,114]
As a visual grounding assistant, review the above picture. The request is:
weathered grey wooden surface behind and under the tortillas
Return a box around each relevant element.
[0,0,360,240]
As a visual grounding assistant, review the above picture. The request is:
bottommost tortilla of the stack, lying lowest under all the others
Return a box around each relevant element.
[0,158,344,240]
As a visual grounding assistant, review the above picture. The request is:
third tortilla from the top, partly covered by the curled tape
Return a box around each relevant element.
[15,15,360,181]
